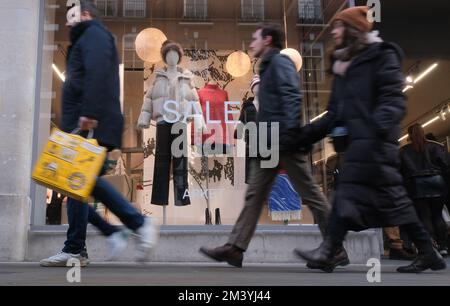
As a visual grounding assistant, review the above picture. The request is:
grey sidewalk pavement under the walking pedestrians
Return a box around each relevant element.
[0,259,450,286]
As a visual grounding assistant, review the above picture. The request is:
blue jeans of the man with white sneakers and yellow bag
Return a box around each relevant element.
[63,178,144,254]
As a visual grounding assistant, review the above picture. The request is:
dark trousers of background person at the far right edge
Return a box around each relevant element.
[414,198,447,247]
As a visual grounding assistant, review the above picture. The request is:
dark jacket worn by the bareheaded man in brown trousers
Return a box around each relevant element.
[257,49,302,151]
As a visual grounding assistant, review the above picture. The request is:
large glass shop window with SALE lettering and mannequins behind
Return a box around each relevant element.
[35,0,346,225]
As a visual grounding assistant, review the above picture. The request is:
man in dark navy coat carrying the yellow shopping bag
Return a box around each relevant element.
[41,1,157,267]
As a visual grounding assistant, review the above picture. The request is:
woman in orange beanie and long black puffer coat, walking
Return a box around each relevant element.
[295,7,446,273]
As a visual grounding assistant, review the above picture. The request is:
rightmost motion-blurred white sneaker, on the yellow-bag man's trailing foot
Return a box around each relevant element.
[136,217,159,261]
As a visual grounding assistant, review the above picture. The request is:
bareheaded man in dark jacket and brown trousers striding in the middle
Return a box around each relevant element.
[200,24,330,267]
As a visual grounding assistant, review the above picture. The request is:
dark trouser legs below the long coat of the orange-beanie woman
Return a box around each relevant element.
[327,205,434,255]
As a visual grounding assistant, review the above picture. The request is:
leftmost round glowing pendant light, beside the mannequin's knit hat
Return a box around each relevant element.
[136,28,167,63]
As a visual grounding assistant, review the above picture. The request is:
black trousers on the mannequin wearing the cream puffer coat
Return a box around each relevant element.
[152,122,191,206]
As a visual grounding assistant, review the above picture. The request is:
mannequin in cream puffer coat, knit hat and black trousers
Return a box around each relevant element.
[138,42,203,206]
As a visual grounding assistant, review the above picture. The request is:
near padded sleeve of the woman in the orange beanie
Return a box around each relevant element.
[373,49,406,137]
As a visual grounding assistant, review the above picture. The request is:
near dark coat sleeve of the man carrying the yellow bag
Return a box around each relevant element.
[80,26,119,120]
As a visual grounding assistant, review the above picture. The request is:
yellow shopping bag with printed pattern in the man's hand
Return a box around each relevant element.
[32,128,106,203]
